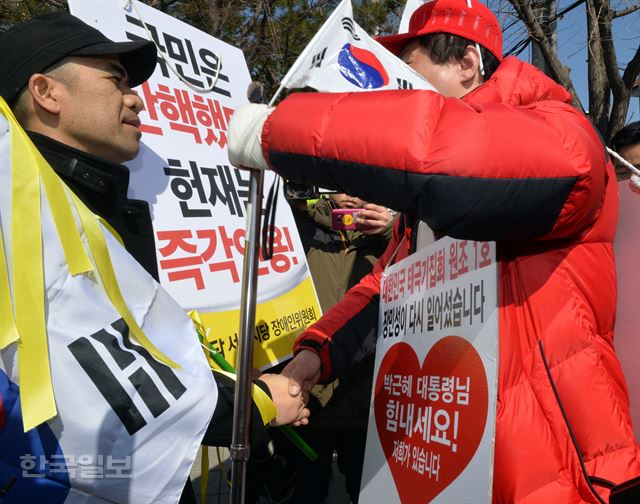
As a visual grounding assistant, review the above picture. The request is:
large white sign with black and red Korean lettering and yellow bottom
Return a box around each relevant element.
[69,0,320,368]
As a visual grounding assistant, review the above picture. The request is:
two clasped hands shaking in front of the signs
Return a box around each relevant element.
[260,350,321,426]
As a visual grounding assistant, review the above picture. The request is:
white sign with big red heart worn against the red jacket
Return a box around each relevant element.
[360,237,498,504]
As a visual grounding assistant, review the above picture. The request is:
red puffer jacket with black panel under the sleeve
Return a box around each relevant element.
[263,58,640,504]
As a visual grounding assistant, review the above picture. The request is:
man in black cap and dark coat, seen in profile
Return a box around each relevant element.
[0,12,308,502]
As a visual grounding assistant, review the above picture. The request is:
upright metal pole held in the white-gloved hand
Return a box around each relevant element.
[230,166,264,504]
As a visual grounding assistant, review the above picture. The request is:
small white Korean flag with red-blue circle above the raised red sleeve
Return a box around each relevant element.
[281,0,434,92]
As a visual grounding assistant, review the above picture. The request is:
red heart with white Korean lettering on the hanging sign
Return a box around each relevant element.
[374,336,488,504]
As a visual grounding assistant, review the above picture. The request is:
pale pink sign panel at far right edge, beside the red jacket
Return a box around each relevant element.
[614,180,640,440]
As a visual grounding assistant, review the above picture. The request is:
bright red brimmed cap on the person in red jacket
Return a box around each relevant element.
[376,0,502,61]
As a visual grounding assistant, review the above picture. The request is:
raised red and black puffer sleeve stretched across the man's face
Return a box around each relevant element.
[262,61,607,240]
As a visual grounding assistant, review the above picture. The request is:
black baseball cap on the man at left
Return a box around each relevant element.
[0,12,157,103]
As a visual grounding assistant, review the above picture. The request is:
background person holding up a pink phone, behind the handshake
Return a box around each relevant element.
[277,193,395,504]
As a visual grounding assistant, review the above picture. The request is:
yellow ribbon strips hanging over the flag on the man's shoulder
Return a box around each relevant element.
[0,98,179,432]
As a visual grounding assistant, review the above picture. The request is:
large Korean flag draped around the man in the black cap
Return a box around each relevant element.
[0,99,217,504]
